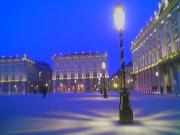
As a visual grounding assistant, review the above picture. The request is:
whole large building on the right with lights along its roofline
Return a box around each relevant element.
[131,0,180,92]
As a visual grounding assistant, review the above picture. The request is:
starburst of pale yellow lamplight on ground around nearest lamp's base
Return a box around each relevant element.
[1,110,180,135]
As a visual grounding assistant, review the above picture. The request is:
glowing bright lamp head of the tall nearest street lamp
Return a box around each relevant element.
[114,5,125,31]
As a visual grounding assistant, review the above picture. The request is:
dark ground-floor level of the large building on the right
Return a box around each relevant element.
[135,58,180,93]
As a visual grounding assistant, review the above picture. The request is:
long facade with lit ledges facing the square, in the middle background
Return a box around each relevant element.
[52,53,109,92]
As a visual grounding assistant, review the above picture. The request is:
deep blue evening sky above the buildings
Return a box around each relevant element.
[0,0,160,74]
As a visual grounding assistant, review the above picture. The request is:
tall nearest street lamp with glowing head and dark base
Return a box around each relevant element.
[114,4,133,123]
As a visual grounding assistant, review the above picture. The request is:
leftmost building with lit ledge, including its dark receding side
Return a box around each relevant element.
[0,55,52,94]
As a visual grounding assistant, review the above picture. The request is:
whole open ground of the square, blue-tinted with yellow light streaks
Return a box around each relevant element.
[0,92,180,135]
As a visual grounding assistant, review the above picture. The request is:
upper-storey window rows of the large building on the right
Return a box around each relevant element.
[133,10,180,71]
